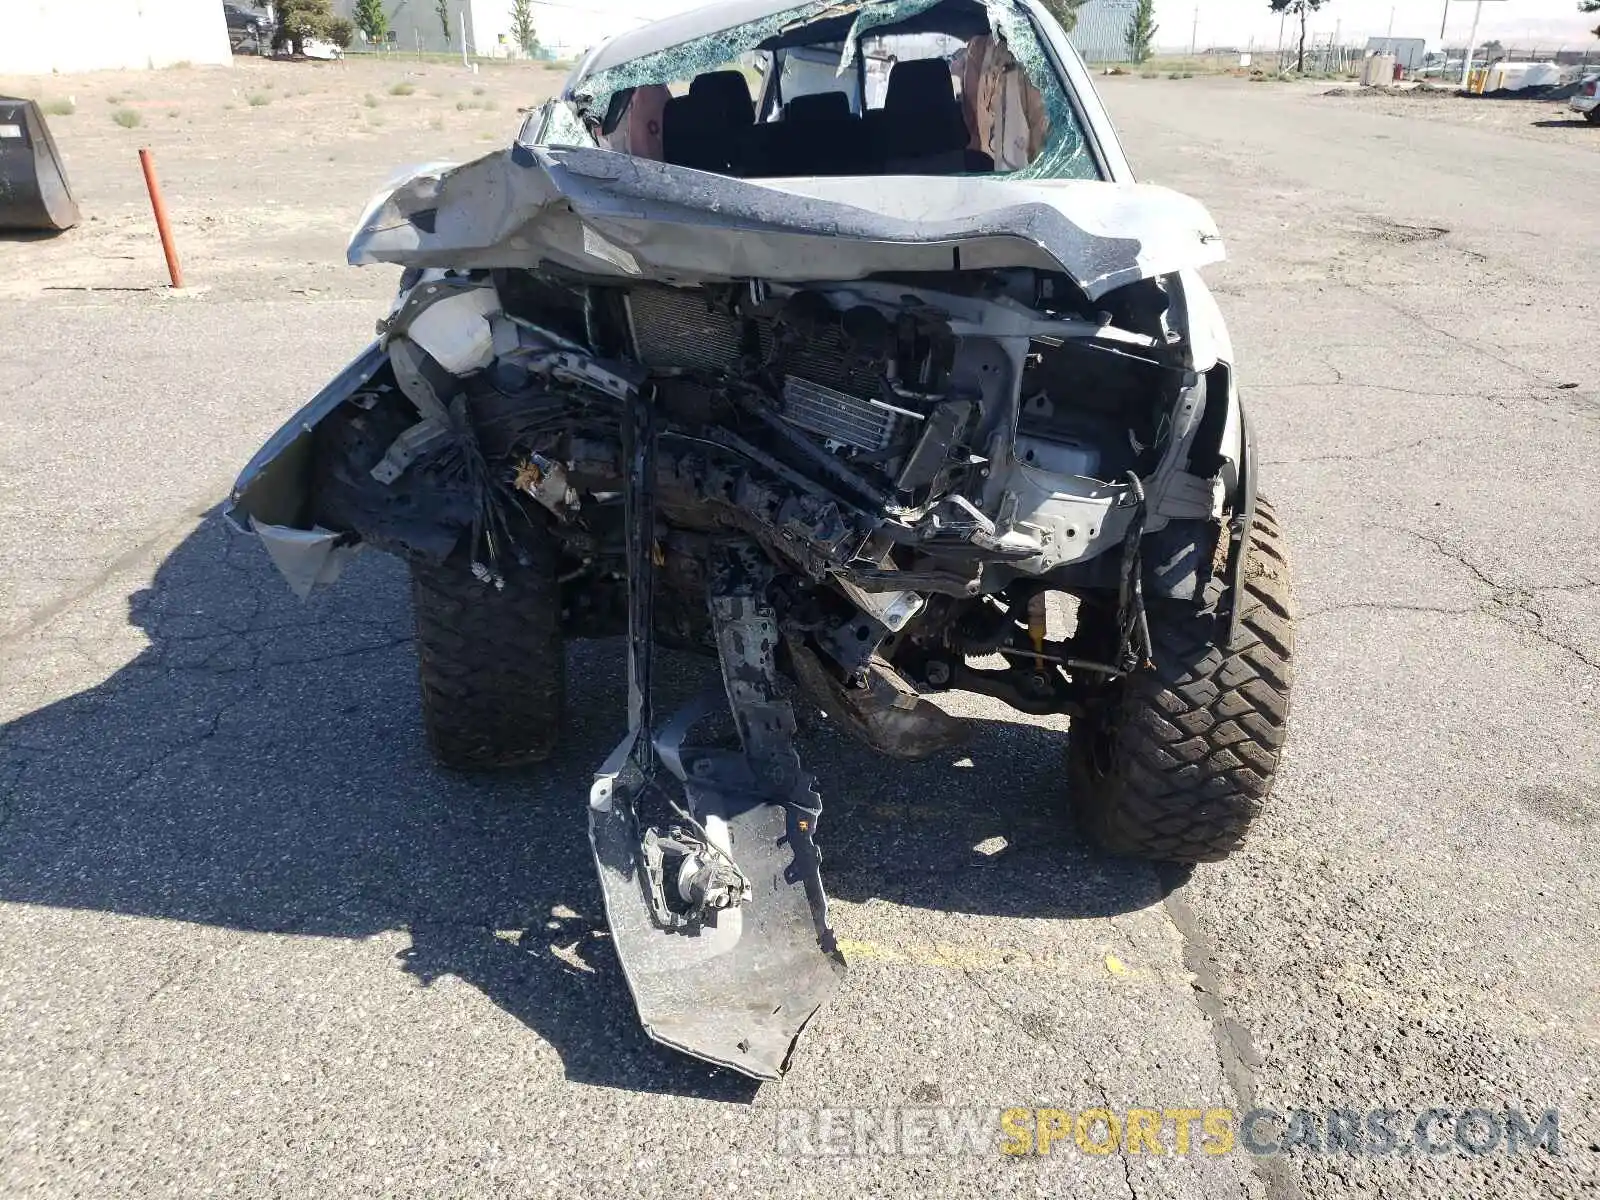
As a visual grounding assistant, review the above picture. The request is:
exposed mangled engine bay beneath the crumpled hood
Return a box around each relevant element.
[278,269,1210,732]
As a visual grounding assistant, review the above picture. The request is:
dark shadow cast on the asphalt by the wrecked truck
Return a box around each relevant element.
[0,517,1163,1101]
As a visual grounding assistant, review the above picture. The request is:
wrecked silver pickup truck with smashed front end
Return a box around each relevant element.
[229,0,1291,1078]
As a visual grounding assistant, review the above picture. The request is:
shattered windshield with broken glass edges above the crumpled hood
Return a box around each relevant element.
[539,0,1099,179]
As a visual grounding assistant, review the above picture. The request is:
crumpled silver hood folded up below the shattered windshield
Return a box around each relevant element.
[349,144,1222,299]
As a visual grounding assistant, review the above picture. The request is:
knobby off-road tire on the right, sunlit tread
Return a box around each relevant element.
[1067,499,1294,862]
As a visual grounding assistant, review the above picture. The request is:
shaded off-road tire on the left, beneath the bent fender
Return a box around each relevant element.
[411,544,566,771]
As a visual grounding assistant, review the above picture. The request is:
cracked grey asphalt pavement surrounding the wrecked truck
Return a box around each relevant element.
[0,72,1600,1200]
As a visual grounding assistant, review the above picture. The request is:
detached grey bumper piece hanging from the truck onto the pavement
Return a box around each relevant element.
[589,397,845,1080]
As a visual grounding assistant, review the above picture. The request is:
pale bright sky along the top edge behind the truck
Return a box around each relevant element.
[534,0,1600,51]
